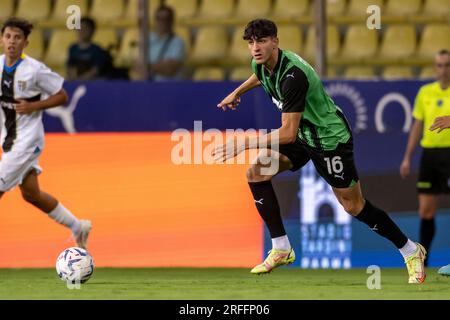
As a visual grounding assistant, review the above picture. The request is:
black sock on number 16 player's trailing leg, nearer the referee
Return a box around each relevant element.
[355,199,408,249]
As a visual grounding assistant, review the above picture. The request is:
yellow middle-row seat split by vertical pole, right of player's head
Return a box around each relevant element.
[301,24,340,63]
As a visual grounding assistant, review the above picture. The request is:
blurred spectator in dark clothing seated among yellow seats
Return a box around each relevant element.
[67,18,112,80]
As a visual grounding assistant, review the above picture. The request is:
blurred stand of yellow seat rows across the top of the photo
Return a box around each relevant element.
[0,0,450,78]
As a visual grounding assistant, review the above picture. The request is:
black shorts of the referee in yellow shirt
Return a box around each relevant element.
[417,148,450,194]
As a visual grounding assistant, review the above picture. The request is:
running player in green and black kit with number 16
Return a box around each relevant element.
[213,19,426,283]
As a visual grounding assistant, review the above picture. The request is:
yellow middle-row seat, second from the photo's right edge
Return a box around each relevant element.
[379,24,417,59]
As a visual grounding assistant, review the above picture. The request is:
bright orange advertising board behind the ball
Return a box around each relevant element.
[0,133,263,268]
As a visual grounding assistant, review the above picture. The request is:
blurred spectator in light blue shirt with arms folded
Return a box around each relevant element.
[149,5,186,81]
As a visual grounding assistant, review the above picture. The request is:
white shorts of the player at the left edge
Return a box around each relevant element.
[0,149,42,192]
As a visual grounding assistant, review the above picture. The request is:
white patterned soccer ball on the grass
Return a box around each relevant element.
[56,247,94,284]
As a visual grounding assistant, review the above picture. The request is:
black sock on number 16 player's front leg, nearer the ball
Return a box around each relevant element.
[248,181,286,239]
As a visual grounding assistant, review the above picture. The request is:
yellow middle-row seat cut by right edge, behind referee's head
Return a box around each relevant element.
[417,24,450,61]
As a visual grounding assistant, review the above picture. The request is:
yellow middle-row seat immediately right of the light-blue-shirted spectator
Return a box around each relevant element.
[191,26,228,64]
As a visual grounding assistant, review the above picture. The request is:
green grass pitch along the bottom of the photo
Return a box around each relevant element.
[0,268,450,300]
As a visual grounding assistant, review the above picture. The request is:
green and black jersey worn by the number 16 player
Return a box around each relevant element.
[252,50,351,150]
